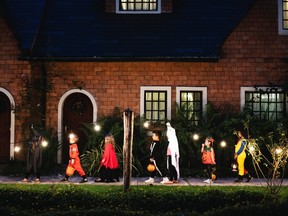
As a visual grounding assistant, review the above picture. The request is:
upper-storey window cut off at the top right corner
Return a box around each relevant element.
[278,0,288,35]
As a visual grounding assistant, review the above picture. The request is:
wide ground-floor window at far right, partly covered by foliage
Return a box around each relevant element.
[241,87,287,121]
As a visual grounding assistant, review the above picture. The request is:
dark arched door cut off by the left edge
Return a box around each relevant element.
[0,92,11,163]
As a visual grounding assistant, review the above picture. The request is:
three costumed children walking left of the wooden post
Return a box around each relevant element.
[22,128,119,183]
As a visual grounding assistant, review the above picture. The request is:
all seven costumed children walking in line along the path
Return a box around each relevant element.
[22,122,253,184]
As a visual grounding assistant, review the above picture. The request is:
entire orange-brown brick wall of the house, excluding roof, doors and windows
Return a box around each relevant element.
[0,0,288,155]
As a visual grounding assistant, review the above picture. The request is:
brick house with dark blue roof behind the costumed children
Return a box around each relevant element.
[0,0,288,163]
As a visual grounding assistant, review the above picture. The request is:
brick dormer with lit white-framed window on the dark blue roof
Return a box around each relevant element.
[105,0,172,14]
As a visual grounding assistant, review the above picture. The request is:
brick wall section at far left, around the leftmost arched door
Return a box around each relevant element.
[0,14,31,159]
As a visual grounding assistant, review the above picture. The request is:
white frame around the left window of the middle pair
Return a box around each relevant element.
[140,86,171,120]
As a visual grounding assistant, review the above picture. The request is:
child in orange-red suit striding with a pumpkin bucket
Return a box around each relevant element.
[61,133,88,183]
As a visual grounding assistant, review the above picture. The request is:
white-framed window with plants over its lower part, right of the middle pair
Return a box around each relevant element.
[176,87,207,125]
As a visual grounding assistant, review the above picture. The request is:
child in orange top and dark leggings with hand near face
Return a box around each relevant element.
[201,137,216,183]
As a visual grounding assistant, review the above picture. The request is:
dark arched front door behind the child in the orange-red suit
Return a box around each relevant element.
[62,93,93,164]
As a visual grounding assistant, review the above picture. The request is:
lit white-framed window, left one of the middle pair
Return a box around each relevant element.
[140,86,171,123]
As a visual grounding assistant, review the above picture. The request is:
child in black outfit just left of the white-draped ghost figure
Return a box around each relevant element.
[145,131,162,184]
